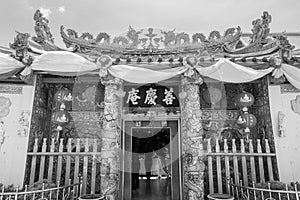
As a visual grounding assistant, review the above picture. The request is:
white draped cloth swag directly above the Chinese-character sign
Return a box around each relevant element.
[108,65,187,84]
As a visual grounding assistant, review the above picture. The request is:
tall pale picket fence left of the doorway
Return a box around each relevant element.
[26,138,101,194]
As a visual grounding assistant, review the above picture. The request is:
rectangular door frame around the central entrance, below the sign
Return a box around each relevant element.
[119,114,183,200]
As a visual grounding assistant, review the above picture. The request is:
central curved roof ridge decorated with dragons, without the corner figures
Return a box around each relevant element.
[61,26,241,56]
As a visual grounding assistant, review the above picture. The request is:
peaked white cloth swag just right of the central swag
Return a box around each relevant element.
[197,58,274,83]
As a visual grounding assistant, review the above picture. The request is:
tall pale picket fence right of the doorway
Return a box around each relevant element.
[204,139,277,193]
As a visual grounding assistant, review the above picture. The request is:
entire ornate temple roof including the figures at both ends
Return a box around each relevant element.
[0,10,299,69]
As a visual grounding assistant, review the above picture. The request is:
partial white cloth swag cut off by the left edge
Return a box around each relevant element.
[0,53,25,80]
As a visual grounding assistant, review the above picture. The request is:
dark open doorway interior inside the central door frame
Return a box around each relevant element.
[131,127,171,200]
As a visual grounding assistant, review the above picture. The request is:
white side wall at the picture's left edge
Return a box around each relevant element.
[0,80,35,186]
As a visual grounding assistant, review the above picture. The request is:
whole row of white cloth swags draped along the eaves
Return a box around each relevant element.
[0,51,300,89]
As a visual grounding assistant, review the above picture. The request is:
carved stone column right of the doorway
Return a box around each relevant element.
[180,77,205,200]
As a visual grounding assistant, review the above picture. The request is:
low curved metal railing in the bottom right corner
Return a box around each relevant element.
[228,181,300,200]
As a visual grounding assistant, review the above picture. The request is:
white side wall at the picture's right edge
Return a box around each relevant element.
[269,85,300,182]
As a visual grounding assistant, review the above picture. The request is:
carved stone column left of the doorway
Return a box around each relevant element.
[101,78,122,200]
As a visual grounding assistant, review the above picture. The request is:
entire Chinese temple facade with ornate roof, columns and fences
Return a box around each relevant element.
[0,11,300,200]
